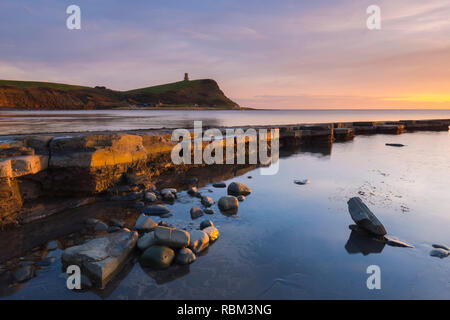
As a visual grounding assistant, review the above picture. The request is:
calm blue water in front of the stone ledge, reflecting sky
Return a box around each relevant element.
[0,132,450,299]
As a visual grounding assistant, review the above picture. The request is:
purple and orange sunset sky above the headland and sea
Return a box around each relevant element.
[0,0,450,109]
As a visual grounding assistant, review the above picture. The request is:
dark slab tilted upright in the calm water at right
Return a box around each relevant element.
[347,197,387,236]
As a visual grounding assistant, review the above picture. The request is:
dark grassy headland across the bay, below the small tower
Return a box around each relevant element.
[0,80,237,110]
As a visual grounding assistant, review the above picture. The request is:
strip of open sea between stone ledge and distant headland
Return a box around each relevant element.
[0,110,450,135]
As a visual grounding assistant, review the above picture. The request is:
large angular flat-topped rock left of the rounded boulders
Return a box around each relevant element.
[62,229,138,288]
